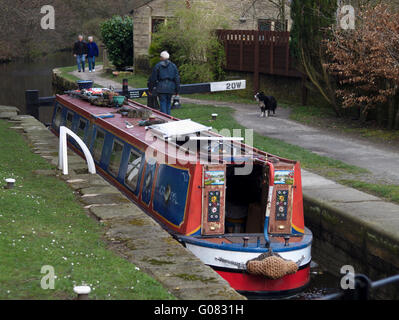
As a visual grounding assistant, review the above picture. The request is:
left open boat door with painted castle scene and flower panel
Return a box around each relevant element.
[201,165,226,235]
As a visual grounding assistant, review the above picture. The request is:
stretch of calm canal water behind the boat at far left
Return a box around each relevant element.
[0,52,75,122]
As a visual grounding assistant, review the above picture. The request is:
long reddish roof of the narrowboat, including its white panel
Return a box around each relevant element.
[56,95,296,165]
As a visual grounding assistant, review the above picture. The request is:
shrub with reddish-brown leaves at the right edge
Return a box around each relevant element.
[326,3,399,129]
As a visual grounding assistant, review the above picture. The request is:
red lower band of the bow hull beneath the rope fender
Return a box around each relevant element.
[215,265,310,293]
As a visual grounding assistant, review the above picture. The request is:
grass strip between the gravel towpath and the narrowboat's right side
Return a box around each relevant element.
[172,104,368,178]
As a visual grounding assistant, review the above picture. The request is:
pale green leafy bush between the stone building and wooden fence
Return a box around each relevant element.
[149,3,227,83]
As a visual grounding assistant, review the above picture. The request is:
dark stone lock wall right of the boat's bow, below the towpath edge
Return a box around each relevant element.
[304,198,399,299]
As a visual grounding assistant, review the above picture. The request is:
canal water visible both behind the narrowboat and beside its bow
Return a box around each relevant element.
[0,52,339,300]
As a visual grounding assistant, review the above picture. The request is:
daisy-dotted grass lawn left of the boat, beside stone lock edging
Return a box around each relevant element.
[0,121,174,300]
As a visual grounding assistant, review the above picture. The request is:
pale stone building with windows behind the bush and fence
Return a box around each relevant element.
[133,0,291,68]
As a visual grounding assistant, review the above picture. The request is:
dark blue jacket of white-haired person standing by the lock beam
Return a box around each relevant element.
[148,60,180,94]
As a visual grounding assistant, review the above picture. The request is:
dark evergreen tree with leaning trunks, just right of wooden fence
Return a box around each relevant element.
[291,0,340,116]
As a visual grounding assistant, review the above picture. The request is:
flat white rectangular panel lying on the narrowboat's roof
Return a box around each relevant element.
[148,119,212,139]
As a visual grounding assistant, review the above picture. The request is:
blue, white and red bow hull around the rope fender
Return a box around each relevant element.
[179,229,313,296]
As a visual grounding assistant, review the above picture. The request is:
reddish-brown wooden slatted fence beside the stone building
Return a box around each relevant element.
[217,30,303,91]
